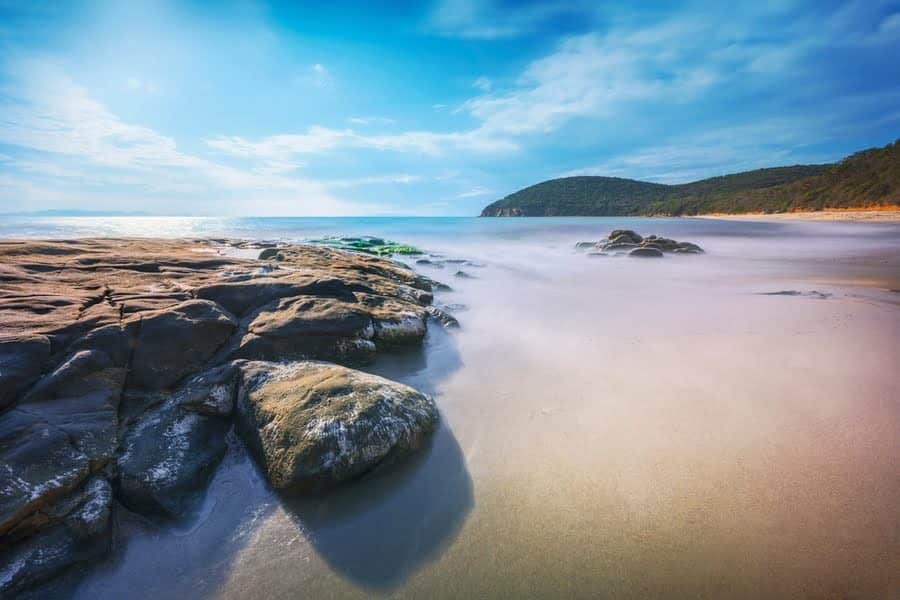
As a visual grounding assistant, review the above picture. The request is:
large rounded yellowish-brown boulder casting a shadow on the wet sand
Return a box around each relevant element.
[236,362,438,493]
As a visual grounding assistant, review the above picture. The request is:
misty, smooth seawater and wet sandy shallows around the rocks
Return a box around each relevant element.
[7,217,900,599]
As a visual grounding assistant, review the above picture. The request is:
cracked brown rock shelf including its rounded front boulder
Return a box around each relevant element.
[0,239,455,597]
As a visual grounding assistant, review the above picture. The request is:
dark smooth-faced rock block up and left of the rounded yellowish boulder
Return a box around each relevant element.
[127,300,237,389]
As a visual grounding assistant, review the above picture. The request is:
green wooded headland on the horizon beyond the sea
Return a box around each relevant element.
[481,140,900,217]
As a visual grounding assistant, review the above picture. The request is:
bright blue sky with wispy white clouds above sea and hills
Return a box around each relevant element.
[0,0,900,216]
